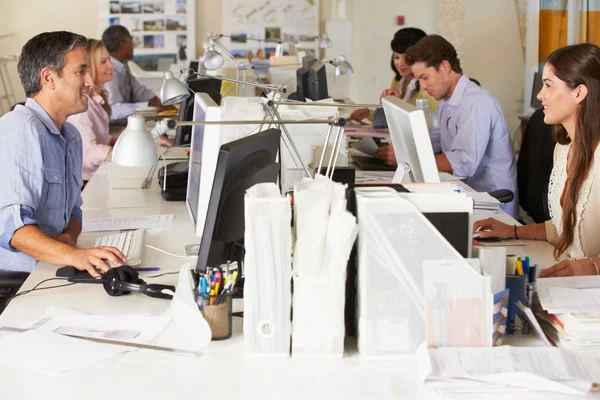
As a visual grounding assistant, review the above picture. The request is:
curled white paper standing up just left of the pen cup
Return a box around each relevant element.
[154,264,212,351]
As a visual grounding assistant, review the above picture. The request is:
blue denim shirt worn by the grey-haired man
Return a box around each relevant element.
[0,98,83,271]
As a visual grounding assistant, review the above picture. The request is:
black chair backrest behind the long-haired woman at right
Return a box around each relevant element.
[517,109,556,222]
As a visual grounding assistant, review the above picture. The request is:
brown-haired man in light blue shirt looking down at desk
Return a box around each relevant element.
[405,35,519,218]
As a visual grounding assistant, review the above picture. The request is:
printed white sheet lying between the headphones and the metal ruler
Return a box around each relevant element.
[37,315,170,344]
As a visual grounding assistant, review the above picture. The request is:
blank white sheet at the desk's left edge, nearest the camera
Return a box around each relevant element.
[0,330,131,375]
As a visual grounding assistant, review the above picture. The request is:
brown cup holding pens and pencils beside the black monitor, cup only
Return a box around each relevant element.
[195,292,233,340]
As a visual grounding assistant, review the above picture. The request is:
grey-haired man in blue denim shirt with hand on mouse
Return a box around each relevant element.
[0,32,125,277]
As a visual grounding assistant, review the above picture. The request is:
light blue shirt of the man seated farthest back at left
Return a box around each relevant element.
[104,57,156,121]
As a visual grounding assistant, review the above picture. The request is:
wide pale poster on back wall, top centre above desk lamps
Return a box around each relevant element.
[219,0,319,59]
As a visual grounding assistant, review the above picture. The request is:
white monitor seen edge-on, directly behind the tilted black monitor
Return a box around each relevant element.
[185,93,221,233]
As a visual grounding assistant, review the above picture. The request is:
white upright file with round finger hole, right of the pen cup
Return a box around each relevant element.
[244,183,292,357]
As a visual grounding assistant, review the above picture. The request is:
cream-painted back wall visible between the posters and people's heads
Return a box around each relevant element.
[0,0,524,137]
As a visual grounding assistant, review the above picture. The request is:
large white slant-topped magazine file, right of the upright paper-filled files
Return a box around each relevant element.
[356,188,466,358]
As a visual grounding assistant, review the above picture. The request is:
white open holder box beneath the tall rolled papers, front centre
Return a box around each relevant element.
[292,277,346,358]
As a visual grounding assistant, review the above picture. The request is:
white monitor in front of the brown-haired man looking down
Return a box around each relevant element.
[382,96,440,183]
